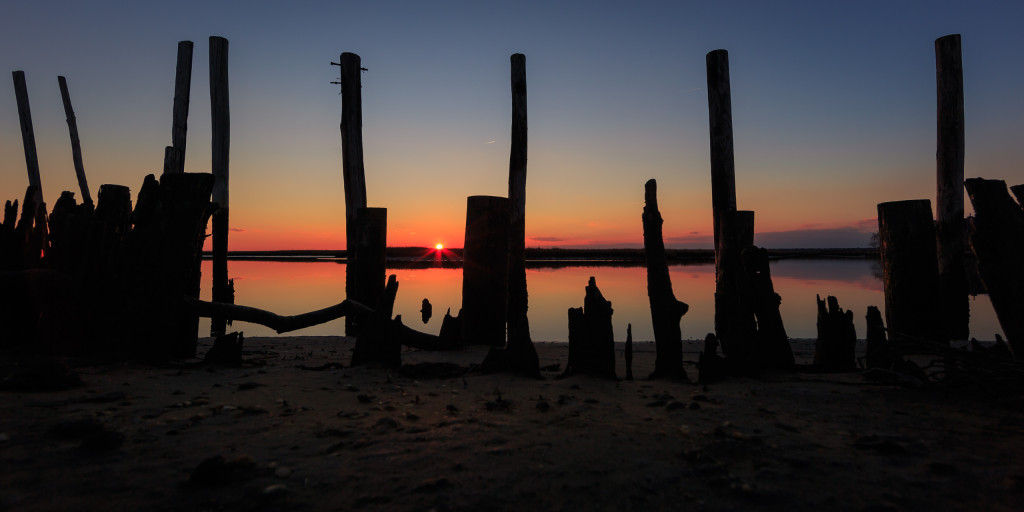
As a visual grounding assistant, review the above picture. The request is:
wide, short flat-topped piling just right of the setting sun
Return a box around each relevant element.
[460,196,509,346]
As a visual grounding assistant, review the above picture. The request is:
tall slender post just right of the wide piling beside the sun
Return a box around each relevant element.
[506,53,540,375]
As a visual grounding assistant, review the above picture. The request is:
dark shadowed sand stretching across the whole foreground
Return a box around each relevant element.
[0,337,1024,511]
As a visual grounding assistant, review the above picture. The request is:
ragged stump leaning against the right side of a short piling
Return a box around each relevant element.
[742,247,796,370]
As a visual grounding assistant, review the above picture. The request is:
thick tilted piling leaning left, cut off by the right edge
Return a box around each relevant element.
[962,178,1024,359]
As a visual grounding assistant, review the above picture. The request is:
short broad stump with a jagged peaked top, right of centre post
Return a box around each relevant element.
[562,278,616,379]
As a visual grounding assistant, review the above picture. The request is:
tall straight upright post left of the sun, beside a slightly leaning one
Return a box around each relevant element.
[210,36,234,336]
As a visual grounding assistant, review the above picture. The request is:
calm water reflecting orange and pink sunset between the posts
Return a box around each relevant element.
[200,259,1001,341]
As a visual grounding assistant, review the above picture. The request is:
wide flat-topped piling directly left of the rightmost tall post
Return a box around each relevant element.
[878,200,948,342]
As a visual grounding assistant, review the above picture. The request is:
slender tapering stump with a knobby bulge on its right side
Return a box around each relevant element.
[642,179,690,380]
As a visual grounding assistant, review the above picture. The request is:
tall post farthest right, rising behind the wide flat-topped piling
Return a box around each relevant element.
[935,34,971,340]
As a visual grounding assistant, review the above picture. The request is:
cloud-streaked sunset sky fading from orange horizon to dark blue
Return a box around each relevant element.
[0,0,1024,250]
